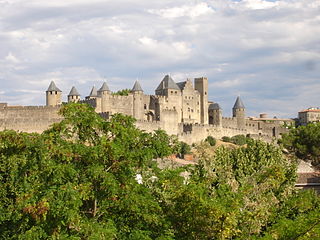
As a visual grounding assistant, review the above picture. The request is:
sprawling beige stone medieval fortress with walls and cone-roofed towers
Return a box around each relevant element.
[0,75,293,143]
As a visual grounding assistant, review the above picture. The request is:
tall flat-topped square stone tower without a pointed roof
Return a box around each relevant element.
[194,77,209,124]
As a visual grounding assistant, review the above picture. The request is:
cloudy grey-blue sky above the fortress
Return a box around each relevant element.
[0,0,320,117]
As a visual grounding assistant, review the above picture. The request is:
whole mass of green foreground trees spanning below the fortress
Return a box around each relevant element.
[0,104,320,240]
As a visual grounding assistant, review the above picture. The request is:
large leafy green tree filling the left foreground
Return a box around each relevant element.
[0,104,175,239]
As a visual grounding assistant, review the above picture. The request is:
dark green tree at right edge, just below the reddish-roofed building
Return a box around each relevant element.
[281,122,320,166]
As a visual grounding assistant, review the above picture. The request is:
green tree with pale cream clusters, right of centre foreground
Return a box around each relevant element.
[159,140,308,239]
